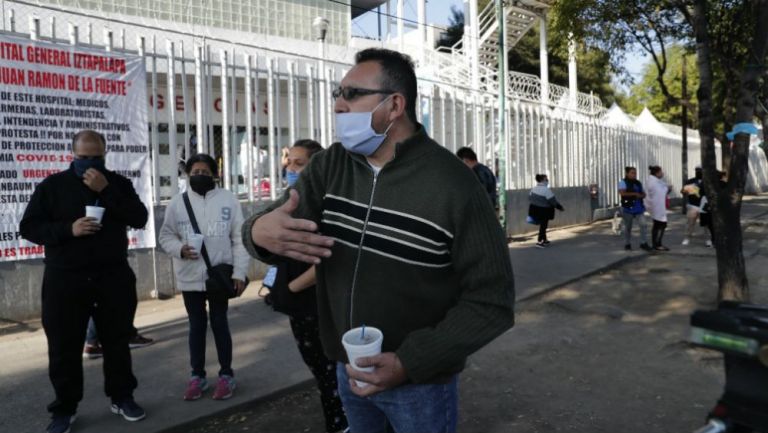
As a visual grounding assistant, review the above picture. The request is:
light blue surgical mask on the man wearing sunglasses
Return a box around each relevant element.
[336,97,392,156]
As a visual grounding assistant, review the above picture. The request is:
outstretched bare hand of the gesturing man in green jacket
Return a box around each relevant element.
[251,190,333,264]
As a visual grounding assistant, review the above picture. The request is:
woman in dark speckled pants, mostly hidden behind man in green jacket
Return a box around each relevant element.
[267,140,347,433]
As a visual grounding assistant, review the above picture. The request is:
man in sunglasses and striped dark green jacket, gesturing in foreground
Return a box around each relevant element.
[243,49,514,433]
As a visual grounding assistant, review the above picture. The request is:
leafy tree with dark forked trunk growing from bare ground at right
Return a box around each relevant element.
[553,0,768,300]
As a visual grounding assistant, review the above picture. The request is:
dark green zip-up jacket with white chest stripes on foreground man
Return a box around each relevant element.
[243,125,515,383]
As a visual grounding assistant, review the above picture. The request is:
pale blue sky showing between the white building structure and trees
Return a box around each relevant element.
[352,0,648,91]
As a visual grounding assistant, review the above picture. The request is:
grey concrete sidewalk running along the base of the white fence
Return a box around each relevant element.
[6,197,768,433]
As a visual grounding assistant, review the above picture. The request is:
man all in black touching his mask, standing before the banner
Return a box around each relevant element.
[19,130,148,433]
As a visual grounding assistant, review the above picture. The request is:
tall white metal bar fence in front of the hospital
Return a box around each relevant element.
[1,0,700,207]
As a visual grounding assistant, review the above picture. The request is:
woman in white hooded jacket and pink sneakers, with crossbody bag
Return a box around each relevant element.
[160,154,249,400]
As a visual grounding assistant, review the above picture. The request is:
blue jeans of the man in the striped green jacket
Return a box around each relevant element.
[336,363,459,433]
